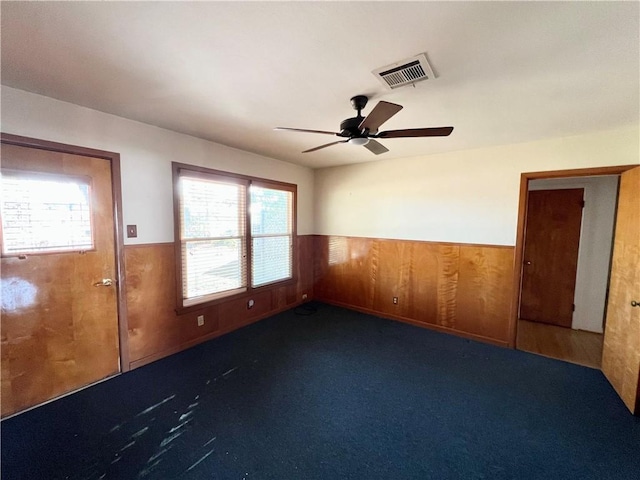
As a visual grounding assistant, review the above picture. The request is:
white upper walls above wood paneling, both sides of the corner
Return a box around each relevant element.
[0,86,640,249]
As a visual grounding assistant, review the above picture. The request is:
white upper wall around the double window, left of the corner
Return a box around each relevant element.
[0,86,313,244]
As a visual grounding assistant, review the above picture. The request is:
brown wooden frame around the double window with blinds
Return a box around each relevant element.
[171,162,298,314]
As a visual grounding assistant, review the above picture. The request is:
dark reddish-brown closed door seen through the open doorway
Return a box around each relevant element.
[520,188,584,328]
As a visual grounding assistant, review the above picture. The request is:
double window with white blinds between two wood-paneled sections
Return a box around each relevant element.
[173,163,296,308]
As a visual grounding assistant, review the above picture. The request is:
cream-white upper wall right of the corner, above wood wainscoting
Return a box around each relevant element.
[314,125,640,245]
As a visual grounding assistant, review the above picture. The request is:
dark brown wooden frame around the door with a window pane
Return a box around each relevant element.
[0,133,130,373]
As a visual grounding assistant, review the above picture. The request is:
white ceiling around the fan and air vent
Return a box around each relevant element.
[0,1,640,168]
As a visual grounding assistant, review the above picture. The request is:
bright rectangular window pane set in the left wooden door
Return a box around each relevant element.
[2,170,94,256]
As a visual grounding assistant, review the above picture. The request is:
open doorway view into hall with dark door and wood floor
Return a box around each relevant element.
[516,175,619,368]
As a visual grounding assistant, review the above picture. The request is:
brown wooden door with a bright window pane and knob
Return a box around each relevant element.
[1,144,120,416]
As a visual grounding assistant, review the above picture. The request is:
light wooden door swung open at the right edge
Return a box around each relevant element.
[602,167,640,415]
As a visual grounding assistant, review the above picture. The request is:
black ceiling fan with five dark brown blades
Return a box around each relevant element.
[274,95,453,155]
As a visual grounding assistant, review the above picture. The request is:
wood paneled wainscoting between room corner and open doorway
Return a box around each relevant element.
[314,235,514,346]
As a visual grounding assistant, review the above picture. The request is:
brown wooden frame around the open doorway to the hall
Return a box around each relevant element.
[509,165,638,348]
